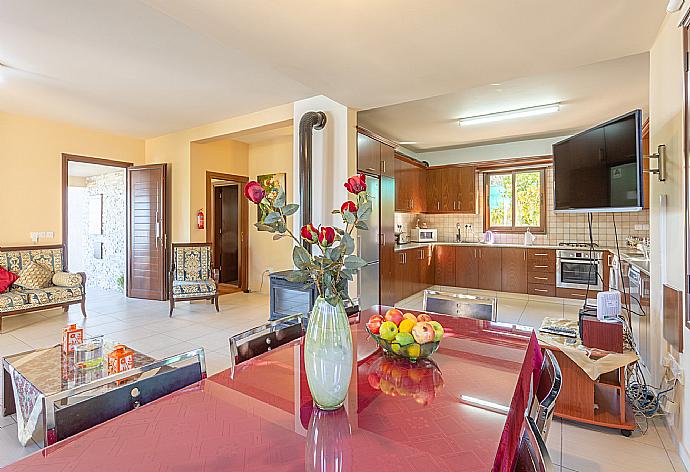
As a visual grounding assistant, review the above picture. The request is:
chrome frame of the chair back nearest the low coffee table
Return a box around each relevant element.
[43,347,206,447]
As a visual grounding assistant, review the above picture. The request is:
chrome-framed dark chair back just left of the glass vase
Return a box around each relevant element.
[230,313,306,377]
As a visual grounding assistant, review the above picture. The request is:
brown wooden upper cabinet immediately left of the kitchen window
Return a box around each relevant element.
[426,166,477,213]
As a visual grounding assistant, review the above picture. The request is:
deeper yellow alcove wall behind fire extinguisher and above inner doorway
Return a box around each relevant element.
[189,139,249,242]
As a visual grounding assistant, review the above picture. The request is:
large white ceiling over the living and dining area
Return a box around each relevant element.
[0,0,666,137]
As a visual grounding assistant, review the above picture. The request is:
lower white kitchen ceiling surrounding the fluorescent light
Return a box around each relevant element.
[358,53,649,152]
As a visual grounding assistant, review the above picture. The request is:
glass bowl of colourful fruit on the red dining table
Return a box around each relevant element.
[366,308,443,362]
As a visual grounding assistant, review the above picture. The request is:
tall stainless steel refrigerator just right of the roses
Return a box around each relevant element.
[357,175,381,310]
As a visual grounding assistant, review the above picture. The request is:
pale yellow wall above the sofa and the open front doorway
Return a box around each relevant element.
[0,113,144,246]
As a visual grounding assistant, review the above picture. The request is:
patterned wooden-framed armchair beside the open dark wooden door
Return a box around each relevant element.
[169,243,220,317]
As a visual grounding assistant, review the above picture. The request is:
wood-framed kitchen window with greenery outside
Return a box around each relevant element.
[484,169,546,233]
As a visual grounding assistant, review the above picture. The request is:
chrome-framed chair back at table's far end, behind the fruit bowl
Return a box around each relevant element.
[424,290,496,321]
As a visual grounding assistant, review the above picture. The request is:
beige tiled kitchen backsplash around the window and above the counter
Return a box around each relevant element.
[395,168,649,247]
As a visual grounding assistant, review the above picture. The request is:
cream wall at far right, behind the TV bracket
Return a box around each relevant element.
[649,13,690,466]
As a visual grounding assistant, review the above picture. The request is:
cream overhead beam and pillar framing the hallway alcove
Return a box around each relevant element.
[146,103,293,242]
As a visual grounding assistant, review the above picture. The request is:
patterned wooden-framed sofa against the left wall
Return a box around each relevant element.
[0,245,86,331]
